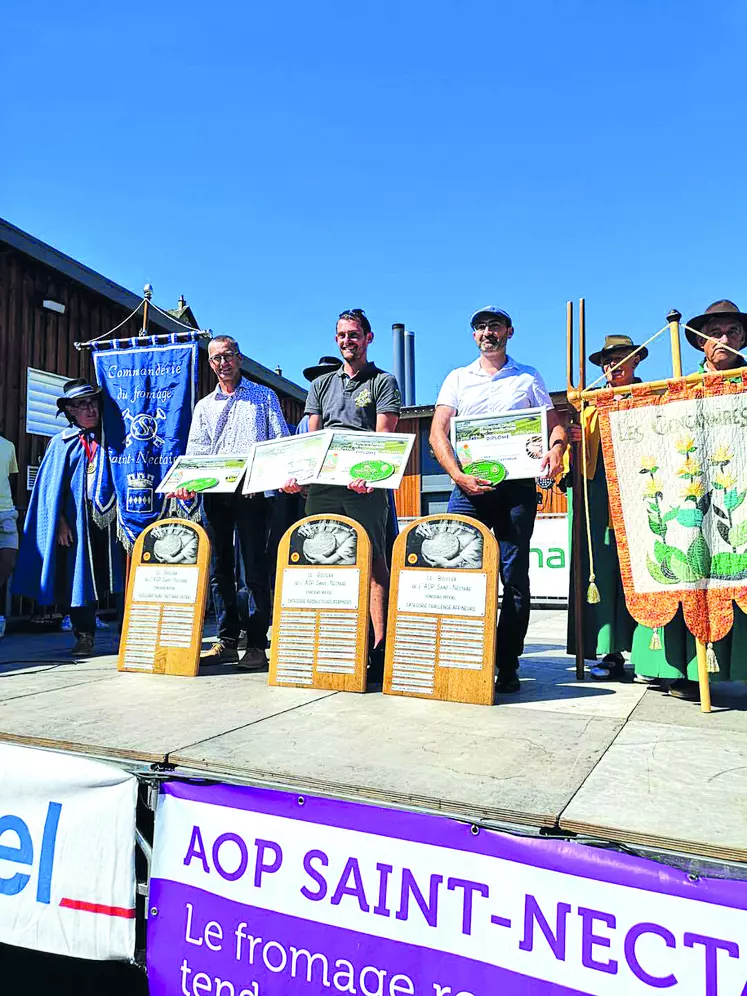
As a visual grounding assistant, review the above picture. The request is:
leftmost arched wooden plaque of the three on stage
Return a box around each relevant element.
[117,519,210,677]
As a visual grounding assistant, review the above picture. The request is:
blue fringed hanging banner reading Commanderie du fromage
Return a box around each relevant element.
[91,332,201,552]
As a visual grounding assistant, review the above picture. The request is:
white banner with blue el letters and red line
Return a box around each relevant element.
[0,744,137,961]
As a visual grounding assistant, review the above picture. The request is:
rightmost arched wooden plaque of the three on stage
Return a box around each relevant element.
[384,514,498,705]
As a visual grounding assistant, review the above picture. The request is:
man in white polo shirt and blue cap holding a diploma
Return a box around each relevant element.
[430,305,567,693]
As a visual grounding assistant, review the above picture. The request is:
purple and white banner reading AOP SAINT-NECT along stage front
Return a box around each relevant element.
[148,783,747,996]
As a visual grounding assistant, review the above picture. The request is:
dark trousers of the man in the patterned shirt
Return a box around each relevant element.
[203,494,270,650]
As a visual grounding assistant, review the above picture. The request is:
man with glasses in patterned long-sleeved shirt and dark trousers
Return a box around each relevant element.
[176,335,289,671]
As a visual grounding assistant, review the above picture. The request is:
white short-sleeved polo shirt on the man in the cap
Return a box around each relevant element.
[436,356,553,415]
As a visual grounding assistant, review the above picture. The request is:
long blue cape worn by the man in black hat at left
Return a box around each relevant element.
[13,427,123,607]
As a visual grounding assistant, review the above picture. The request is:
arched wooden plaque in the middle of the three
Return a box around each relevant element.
[270,515,371,692]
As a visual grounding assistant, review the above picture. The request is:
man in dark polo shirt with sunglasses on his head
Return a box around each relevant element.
[283,308,402,680]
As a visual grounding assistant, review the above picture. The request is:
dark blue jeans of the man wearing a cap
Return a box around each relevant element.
[448,481,537,677]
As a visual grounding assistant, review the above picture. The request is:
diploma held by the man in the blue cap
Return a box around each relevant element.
[451,408,547,484]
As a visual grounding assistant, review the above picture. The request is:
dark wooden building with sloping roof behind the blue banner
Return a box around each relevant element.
[0,219,306,614]
